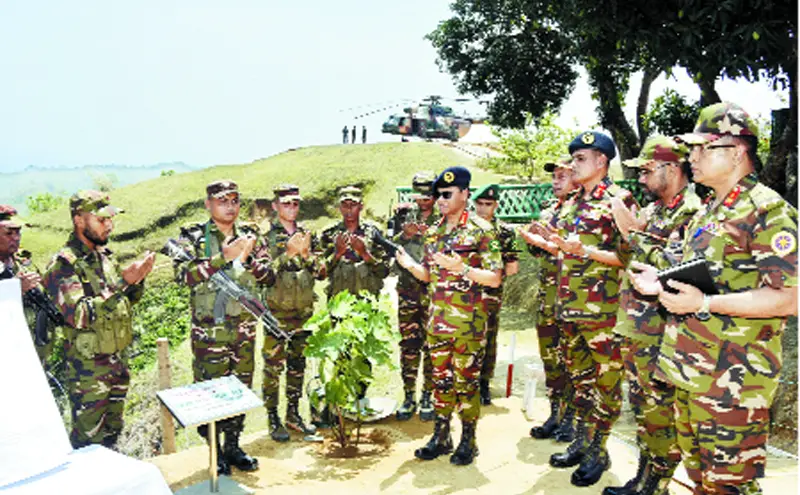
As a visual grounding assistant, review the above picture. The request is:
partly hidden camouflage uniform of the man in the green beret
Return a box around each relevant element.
[481,218,519,388]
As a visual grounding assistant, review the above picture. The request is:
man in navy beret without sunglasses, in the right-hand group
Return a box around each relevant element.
[550,131,636,486]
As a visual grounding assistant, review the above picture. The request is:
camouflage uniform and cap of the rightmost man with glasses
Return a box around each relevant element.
[657,103,797,494]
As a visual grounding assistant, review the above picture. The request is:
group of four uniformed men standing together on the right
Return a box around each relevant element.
[520,102,797,495]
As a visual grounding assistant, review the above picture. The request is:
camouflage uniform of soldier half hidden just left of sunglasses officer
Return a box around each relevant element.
[393,186,441,406]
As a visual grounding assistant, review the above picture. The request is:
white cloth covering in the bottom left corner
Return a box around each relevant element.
[0,279,172,495]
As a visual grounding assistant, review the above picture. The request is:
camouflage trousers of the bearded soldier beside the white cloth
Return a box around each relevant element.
[64,342,131,449]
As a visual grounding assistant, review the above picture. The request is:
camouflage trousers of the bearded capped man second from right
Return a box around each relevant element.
[622,338,681,477]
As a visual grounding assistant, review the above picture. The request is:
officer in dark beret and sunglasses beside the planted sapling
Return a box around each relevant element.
[396,167,502,465]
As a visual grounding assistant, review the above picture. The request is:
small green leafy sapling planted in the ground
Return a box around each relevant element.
[304,291,399,448]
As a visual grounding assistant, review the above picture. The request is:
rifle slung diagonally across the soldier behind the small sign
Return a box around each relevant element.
[161,239,294,341]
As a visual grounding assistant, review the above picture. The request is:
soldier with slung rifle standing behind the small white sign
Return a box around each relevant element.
[175,180,275,474]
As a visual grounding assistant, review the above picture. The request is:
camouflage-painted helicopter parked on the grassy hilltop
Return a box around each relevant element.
[381,95,486,141]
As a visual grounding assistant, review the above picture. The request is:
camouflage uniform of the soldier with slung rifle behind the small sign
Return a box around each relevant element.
[175,181,275,469]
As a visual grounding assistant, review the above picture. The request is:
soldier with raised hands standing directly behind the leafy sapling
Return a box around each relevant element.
[320,186,390,404]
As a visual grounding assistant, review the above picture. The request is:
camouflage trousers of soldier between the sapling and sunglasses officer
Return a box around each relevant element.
[397,291,433,393]
